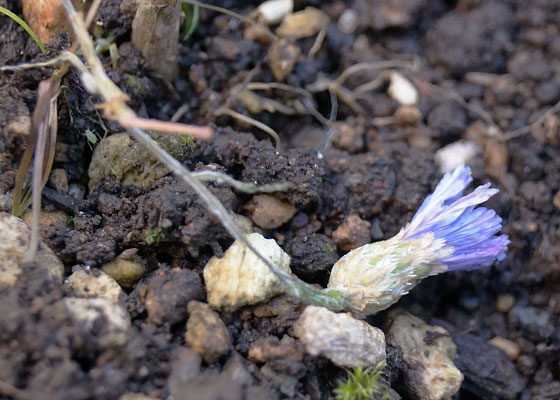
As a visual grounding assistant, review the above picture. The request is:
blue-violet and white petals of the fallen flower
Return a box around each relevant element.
[401,166,509,271]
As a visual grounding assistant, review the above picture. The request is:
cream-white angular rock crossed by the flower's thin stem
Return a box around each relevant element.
[204,233,291,311]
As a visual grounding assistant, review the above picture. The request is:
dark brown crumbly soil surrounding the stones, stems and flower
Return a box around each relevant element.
[0,0,560,399]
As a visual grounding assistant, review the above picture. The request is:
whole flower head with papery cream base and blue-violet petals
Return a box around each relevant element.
[328,166,509,315]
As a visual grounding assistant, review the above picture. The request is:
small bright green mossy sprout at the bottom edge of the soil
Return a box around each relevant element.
[334,360,391,400]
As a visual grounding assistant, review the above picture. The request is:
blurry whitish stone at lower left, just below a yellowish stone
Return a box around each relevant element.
[62,297,130,350]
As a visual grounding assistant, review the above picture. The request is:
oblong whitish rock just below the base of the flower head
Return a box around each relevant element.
[294,306,385,368]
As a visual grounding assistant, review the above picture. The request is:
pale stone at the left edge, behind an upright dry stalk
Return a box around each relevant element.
[0,212,64,286]
